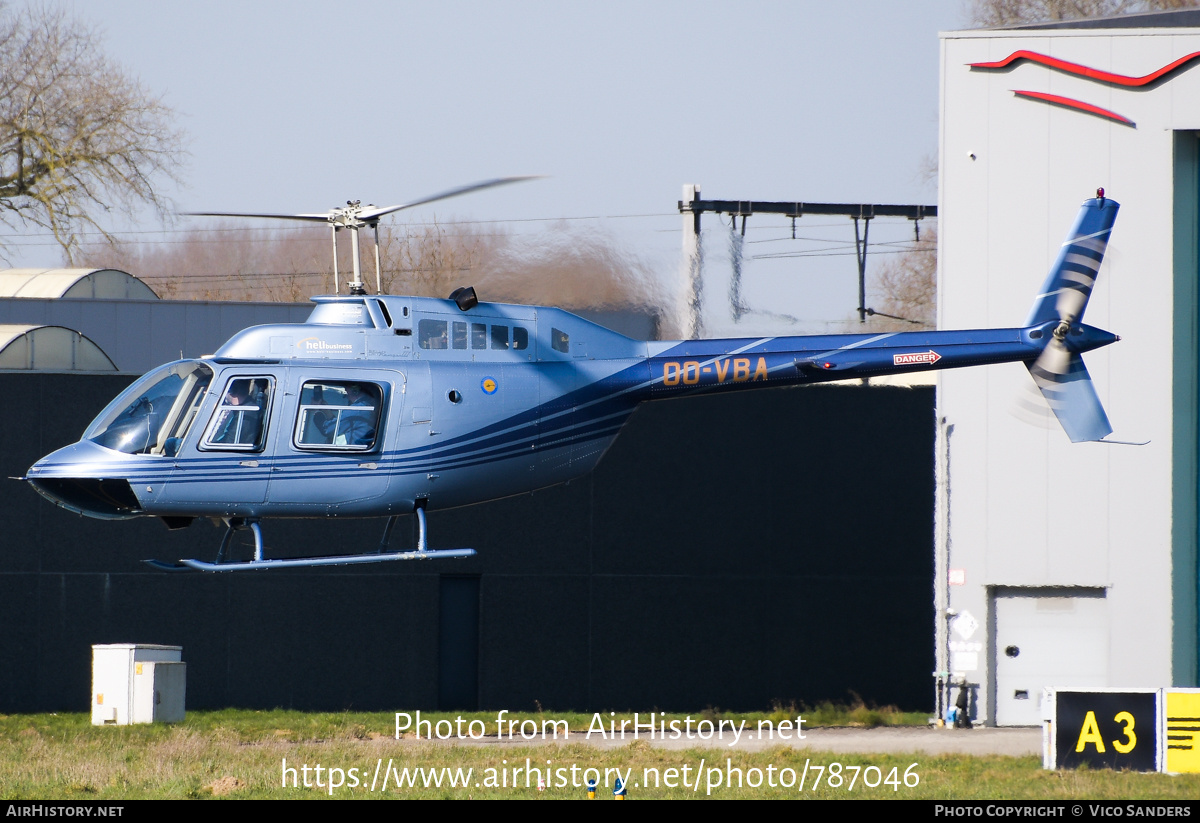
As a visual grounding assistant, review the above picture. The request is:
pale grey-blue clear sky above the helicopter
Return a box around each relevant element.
[14,0,961,331]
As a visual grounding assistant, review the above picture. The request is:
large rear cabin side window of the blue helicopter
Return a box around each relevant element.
[295,380,383,451]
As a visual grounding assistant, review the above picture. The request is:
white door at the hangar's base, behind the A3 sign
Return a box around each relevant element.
[991,587,1109,726]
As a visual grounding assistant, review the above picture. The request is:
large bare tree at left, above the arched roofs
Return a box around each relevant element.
[0,6,184,262]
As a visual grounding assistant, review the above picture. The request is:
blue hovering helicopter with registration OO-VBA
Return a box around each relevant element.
[22,185,1120,572]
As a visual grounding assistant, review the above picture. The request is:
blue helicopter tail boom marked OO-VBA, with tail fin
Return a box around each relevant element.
[643,190,1120,443]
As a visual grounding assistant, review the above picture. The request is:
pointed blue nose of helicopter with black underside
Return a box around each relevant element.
[22,440,142,519]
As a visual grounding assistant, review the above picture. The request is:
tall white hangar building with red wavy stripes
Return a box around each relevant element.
[935,11,1200,725]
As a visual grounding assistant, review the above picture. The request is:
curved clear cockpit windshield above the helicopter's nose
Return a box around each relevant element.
[83,361,212,457]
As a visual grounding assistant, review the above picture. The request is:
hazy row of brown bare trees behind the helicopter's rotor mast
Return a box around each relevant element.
[78,220,670,311]
